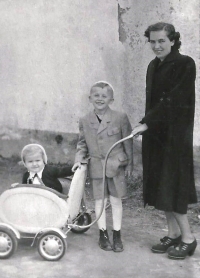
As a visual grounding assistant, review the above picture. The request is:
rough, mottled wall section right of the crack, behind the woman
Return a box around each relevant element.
[118,0,200,145]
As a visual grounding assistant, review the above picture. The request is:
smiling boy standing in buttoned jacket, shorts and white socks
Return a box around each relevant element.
[72,81,133,252]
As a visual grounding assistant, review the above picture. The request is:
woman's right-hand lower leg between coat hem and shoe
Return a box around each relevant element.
[173,212,194,243]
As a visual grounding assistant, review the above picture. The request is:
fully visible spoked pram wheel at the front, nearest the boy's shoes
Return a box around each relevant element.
[38,231,66,261]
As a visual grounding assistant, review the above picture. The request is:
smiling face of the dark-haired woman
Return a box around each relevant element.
[149,30,174,61]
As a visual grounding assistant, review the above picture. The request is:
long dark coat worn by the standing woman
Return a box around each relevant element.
[141,51,197,214]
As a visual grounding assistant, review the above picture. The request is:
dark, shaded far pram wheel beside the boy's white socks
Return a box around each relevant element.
[71,212,92,234]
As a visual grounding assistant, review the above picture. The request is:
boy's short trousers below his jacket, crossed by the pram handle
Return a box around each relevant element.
[90,168,127,200]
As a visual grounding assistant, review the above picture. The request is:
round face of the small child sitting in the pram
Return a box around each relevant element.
[25,153,44,173]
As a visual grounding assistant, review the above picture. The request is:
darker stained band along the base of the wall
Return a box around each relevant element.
[0,129,200,195]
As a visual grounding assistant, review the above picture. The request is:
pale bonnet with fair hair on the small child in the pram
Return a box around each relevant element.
[21,144,47,164]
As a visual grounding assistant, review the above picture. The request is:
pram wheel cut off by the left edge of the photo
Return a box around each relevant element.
[0,227,18,259]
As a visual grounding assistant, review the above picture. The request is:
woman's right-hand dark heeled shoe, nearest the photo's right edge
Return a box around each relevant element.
[168,239,197,260]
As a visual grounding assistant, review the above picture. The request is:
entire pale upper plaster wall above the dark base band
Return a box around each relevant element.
[0,0,200,145]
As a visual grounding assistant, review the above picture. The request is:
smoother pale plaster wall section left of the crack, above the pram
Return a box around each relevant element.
[0,0,124,132]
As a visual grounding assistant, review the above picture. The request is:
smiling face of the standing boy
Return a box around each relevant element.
[89,87,114,114]
